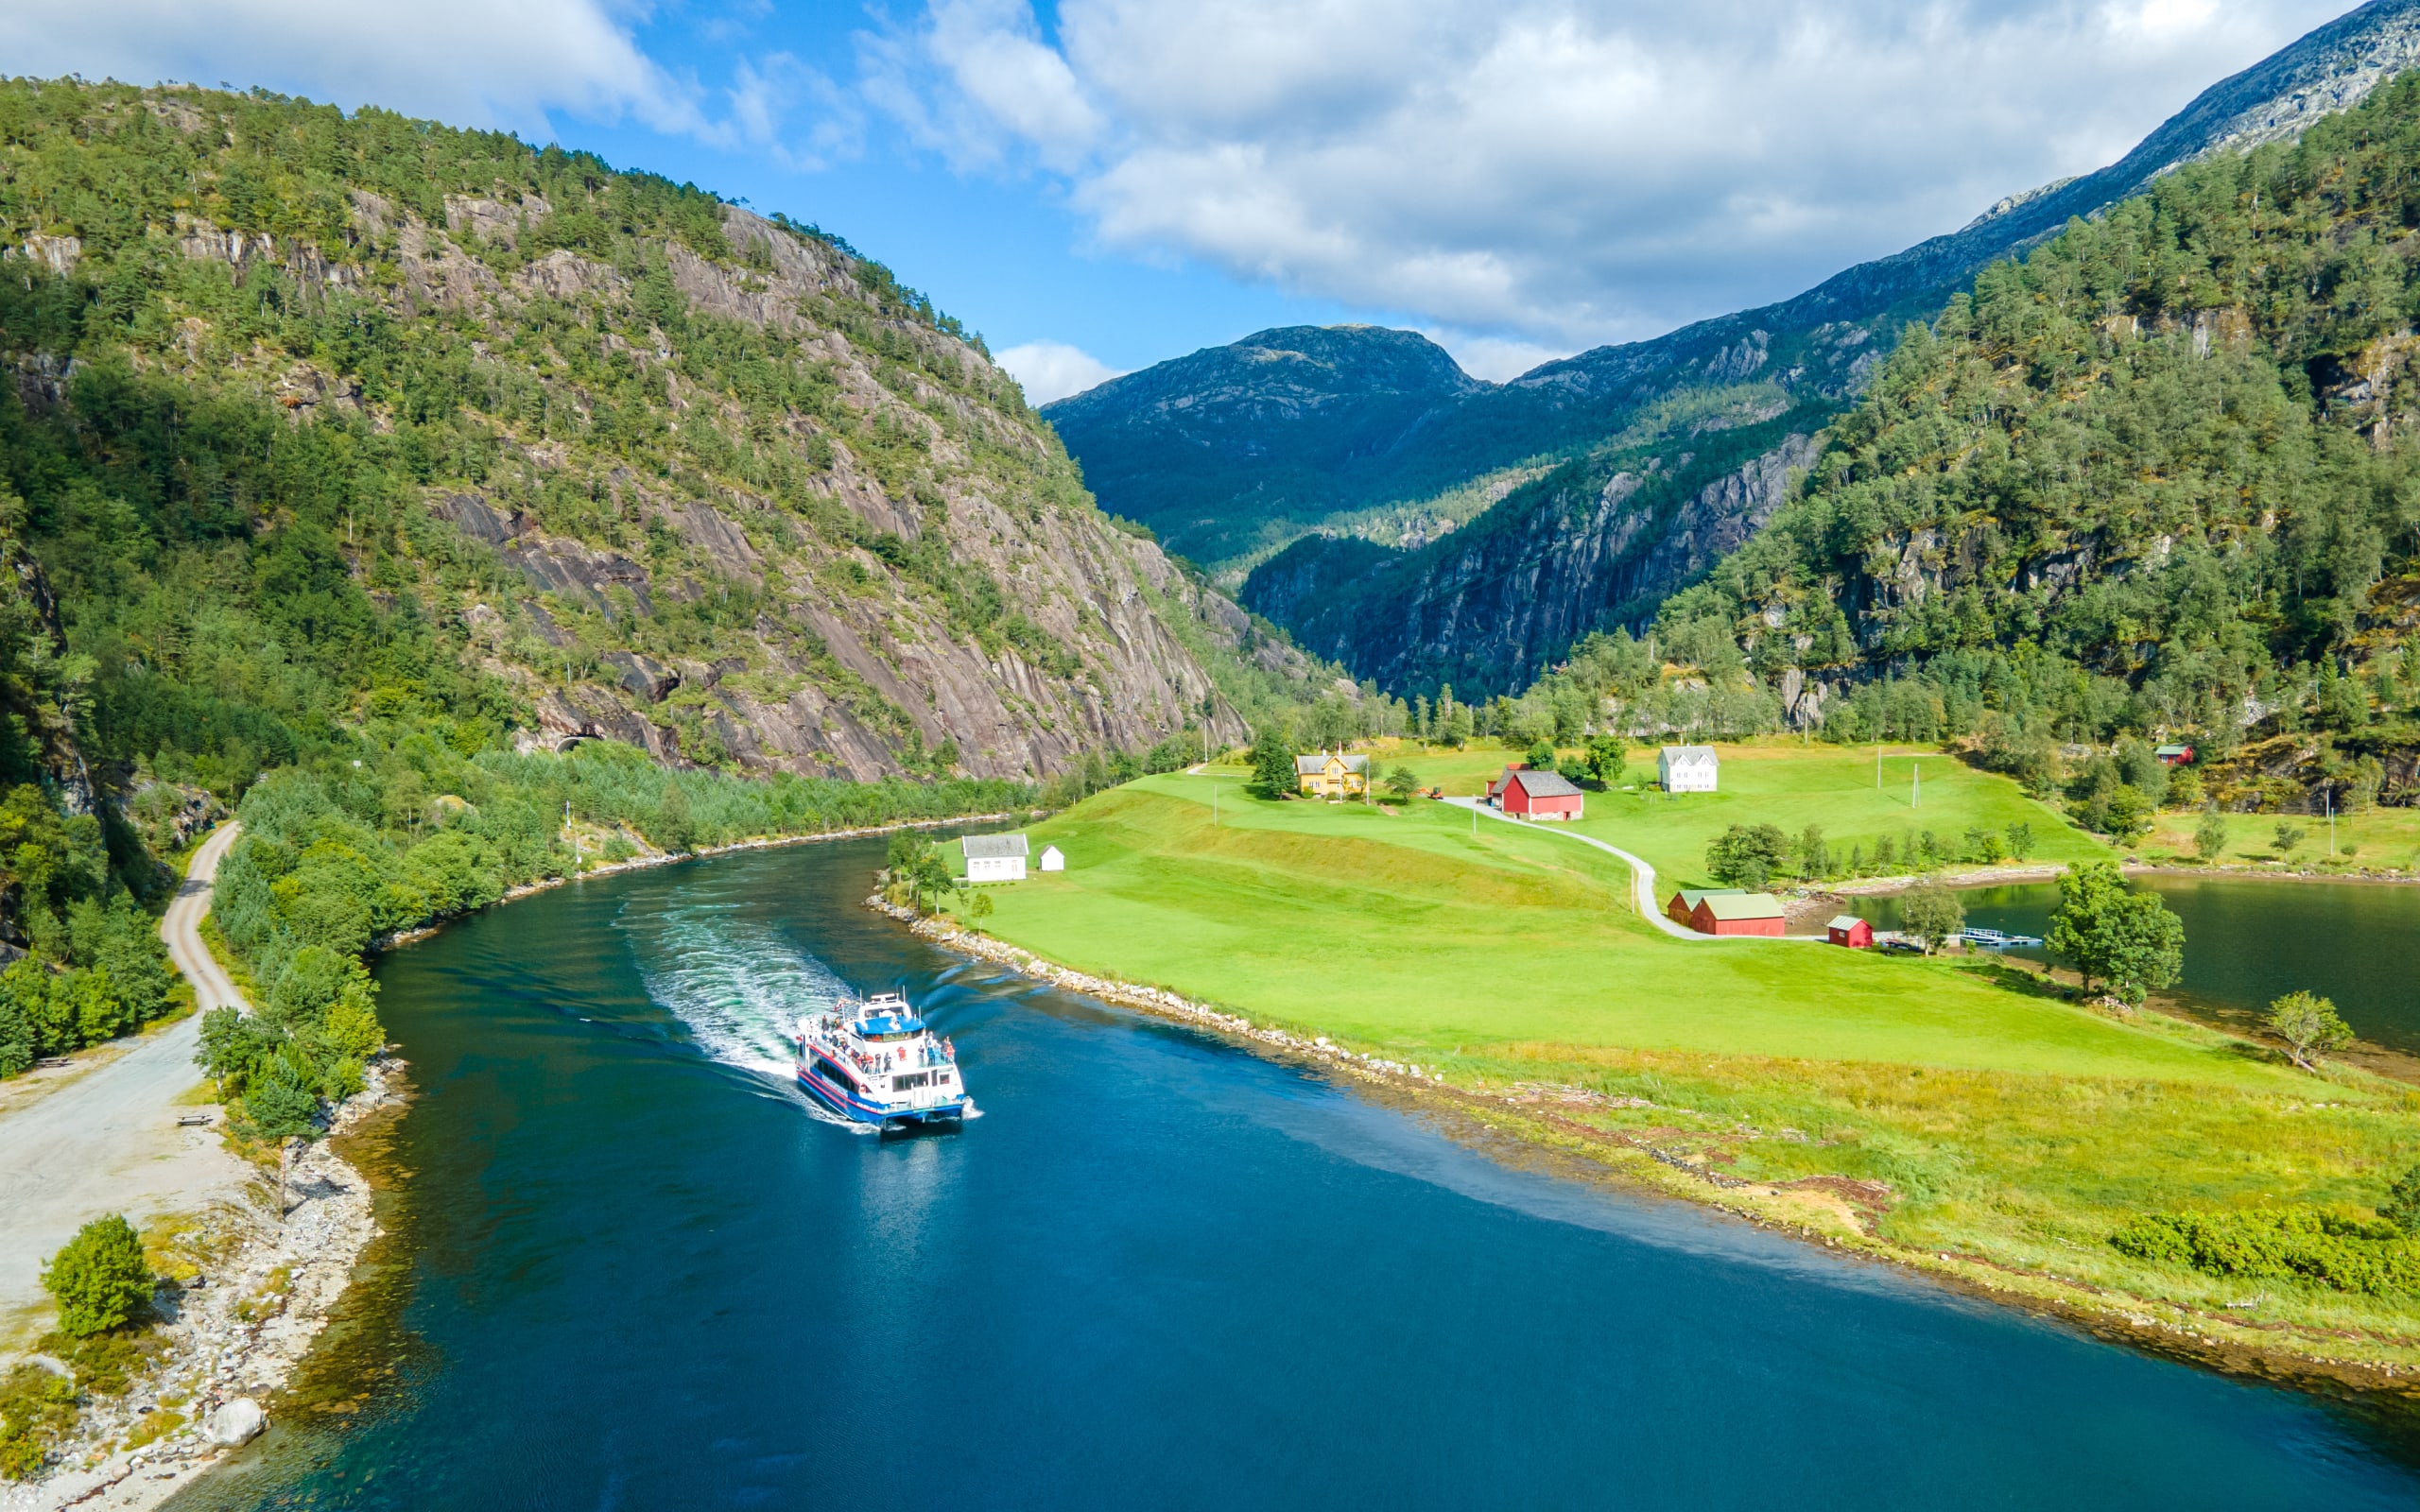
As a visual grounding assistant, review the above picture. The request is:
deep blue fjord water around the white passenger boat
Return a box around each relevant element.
[174,842,2420,1509]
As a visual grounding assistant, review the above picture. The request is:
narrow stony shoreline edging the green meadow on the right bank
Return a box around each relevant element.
[866,893,2420,1396]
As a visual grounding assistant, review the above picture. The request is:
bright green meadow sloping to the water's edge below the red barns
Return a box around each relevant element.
[948,774,2420,1365]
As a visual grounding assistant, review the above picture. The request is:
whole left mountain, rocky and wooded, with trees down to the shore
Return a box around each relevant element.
[0,79,1357,1078]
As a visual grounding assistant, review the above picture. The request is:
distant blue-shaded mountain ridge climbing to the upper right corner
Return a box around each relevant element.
[1046,0,2420,695]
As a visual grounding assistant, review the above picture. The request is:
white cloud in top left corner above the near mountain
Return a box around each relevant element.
[0,0,706,135]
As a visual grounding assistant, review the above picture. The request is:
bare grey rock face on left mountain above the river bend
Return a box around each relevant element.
[312,196,1323,779]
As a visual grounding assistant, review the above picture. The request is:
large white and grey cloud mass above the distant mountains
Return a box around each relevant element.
[864,0,2345,351]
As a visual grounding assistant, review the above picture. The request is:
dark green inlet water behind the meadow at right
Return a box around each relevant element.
[1851,873,2420,1055]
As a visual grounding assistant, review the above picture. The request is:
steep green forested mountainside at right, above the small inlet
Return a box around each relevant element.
[1660,75,2420,760]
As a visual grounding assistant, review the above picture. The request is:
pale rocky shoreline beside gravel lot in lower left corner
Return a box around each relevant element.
[0,1057,405,1512]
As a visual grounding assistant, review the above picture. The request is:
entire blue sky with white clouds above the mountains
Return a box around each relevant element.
[0,0,2345,399]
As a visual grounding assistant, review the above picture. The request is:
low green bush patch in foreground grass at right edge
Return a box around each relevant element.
[2110,1207,2420,1297]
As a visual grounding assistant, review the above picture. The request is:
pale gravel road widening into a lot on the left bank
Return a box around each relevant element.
[0,825,251,1343]
